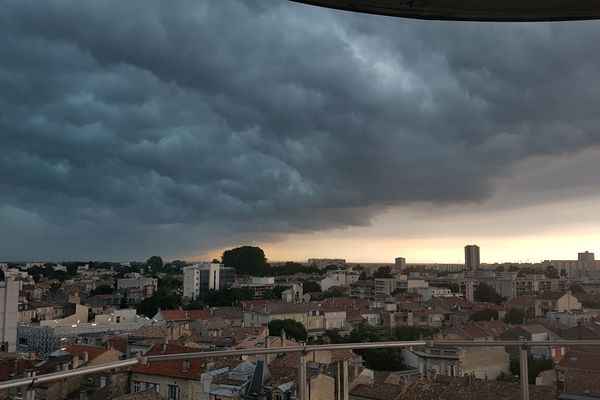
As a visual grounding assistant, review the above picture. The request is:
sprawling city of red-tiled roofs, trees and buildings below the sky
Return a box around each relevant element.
[0,244,600,400]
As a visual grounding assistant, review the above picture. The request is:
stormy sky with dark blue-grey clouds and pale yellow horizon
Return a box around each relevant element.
[0,0,600,263]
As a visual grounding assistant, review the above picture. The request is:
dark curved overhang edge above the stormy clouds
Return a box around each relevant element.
[292,0,600,22]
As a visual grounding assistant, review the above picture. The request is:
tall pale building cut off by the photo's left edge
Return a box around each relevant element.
[0,280,19,352]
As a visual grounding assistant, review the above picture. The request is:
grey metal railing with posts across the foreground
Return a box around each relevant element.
[0,339,600,400]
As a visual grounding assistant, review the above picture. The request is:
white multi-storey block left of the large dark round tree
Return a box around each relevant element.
[183,263,235,299]
